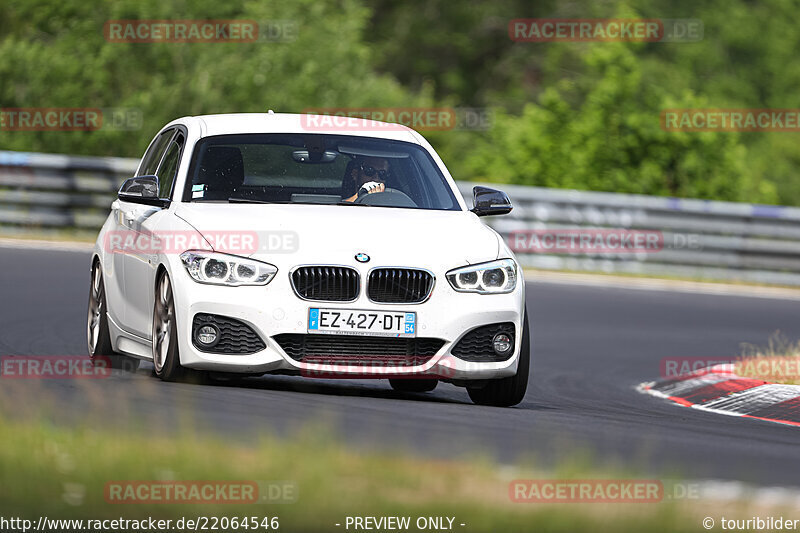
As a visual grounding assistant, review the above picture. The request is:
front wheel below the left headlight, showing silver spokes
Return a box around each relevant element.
[152,272,186,381]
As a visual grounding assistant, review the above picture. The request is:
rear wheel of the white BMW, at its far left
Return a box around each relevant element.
[86,261,139,372]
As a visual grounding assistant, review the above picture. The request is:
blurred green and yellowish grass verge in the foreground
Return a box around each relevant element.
[0,418,698,533]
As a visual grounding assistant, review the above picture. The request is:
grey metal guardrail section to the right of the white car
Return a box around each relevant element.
[459,182,800,285]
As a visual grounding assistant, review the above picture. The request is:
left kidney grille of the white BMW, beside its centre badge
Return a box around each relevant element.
[292,266,360,302]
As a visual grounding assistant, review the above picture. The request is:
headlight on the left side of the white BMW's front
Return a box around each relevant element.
[181,250,278,287]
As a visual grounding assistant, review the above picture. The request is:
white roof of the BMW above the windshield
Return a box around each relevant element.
[169,113,419,144]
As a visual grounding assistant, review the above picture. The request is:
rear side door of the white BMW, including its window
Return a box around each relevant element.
[106,128,175,331]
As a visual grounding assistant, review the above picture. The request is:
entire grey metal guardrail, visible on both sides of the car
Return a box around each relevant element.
[0,151,800,285]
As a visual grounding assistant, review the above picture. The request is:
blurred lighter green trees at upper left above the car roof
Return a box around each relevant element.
[0,0,416,157]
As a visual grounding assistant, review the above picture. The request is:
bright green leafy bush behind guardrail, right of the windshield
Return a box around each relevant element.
[444,44,747,200]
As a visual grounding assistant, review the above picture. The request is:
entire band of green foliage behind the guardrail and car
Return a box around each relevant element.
[0,0,800,204]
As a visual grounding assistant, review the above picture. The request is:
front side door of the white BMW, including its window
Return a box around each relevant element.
[125,131,186,338]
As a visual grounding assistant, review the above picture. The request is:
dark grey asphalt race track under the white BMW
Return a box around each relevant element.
[0,248,800,486]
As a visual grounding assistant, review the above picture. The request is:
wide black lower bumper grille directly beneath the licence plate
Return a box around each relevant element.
[273,333,444,366]
